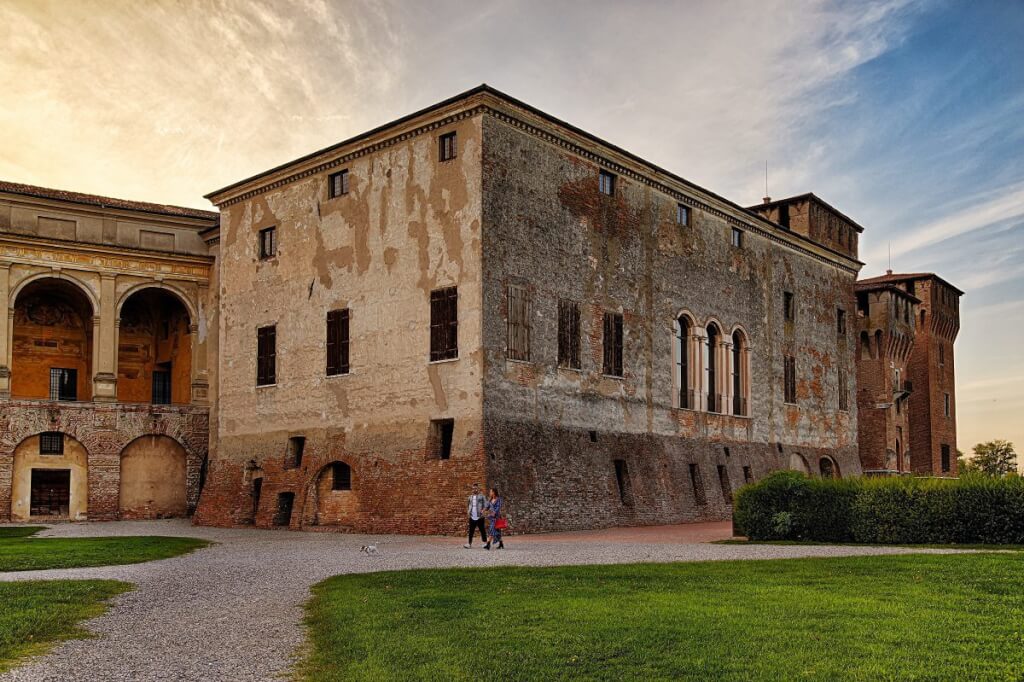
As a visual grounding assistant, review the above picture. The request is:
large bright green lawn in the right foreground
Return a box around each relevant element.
[299,554,1024,680]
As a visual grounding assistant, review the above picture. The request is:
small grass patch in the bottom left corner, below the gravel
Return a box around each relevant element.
[0,577,131,672]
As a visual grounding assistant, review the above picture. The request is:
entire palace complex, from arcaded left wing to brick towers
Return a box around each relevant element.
[0,86,958,532]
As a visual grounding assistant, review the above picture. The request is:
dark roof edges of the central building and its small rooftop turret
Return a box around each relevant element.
[204,83,864,269]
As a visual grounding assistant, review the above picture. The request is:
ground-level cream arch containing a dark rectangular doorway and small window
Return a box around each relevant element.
[10,431,89,521]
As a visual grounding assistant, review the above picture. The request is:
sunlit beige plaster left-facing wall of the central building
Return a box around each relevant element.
[197,118,491,532]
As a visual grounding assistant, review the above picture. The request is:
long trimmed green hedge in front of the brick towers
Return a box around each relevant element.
[733,471,1024,545]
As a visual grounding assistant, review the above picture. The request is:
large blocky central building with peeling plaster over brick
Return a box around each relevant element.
[196,86,861,532]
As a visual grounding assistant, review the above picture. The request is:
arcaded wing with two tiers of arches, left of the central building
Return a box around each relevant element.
[0,182,217,521]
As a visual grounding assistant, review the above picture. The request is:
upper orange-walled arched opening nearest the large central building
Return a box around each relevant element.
[118,288,191,404]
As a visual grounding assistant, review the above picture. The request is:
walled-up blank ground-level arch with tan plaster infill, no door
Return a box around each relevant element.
[118,435,188,518]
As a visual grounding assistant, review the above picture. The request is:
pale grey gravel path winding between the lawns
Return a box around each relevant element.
[0,520,974,682]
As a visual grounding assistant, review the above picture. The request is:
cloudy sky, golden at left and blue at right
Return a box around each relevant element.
[0,0,1024,461]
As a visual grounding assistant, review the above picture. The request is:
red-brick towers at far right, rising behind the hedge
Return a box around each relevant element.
[857,270,964,476]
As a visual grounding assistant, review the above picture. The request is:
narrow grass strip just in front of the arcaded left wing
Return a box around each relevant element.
[0,526,210,571]
